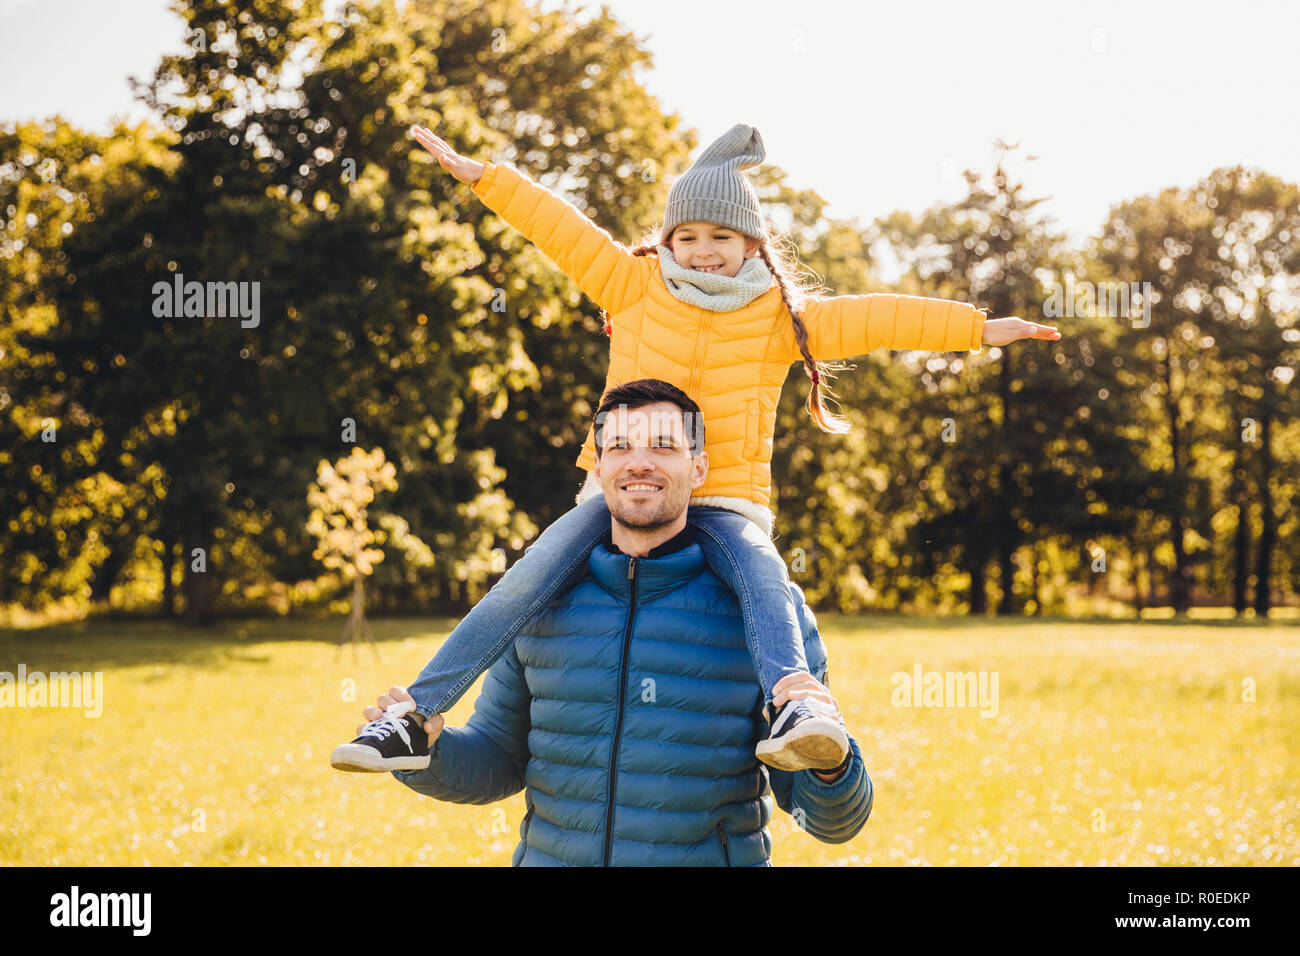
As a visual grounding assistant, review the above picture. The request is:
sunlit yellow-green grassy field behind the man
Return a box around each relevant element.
[0,615,1300,866]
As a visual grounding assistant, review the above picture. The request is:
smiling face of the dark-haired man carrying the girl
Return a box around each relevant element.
[594,402,709,531]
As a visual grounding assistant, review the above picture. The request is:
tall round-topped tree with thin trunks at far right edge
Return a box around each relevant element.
[1096,166,1300,615]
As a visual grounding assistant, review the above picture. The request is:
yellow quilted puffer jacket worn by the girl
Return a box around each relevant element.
[473,163,984,515]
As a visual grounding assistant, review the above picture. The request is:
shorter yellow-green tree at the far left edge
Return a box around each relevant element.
[0,117,183,609]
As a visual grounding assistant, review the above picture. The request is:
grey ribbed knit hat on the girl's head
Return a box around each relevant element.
[659,122,767,243]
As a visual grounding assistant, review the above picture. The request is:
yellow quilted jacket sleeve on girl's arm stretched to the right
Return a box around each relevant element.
[787,293,985,362]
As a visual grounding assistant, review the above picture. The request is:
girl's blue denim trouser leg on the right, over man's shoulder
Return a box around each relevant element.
[686,505,809,705]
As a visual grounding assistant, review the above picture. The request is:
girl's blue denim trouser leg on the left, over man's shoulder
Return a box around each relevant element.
[407,497,610,719]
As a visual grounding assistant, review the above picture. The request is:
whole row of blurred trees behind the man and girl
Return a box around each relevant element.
[0,0,1300,629]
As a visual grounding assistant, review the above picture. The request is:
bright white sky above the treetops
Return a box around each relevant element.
[0,0,1300,251]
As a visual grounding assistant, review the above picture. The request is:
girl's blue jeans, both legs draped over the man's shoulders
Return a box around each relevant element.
[407,496,809,719]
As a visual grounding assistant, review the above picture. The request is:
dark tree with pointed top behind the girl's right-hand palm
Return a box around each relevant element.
[878,147,1145,614]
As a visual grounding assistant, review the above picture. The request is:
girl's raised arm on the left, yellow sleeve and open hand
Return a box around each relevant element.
[412,126,651,316]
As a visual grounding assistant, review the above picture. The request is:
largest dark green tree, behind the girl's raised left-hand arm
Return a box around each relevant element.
[2,3,689,618]
